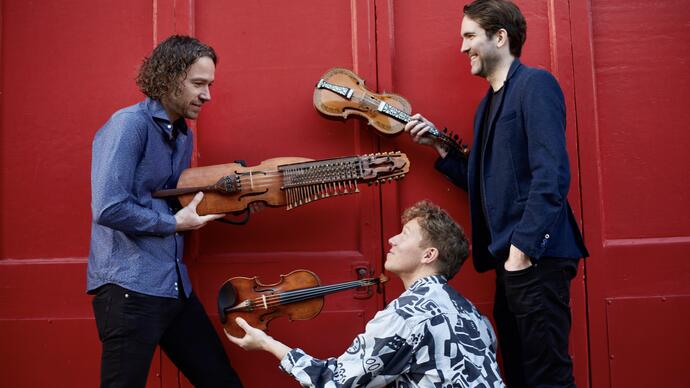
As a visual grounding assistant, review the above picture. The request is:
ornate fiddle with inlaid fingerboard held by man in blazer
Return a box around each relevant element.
[314,67,469,157]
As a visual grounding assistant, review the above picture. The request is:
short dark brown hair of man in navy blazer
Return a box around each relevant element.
[462,0,527,58]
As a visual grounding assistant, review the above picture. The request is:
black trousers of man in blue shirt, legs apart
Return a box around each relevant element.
[93,284,242,387]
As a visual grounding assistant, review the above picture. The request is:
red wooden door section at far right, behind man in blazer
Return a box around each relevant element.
[571,0,690,387]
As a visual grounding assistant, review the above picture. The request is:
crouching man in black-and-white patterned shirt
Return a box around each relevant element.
[228,201,504,387]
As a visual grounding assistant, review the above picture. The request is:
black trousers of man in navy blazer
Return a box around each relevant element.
[494,257,578,388]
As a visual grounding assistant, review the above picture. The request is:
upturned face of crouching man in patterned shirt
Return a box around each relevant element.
[384,219,428,280]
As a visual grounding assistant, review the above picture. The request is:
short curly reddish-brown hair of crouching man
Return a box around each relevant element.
[402,201,469,279]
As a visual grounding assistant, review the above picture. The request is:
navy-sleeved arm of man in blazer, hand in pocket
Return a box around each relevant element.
[510,72,570,259]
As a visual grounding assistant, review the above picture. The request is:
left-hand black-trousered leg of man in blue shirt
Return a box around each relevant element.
[93,284,162,387]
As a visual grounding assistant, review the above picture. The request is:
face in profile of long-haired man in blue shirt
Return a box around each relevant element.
[161,57,216,122]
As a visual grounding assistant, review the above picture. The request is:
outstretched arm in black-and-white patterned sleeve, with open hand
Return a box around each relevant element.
[228,309,414,387]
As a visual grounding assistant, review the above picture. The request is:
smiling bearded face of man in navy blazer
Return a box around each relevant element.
[460,16,501,78]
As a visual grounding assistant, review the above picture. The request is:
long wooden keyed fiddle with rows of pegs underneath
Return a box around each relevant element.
[153,152,410,215]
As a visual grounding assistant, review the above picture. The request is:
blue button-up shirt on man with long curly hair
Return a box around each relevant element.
[87,99,192,298]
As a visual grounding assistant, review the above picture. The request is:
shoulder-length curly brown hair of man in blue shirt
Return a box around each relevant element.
[137,35,218,100]
